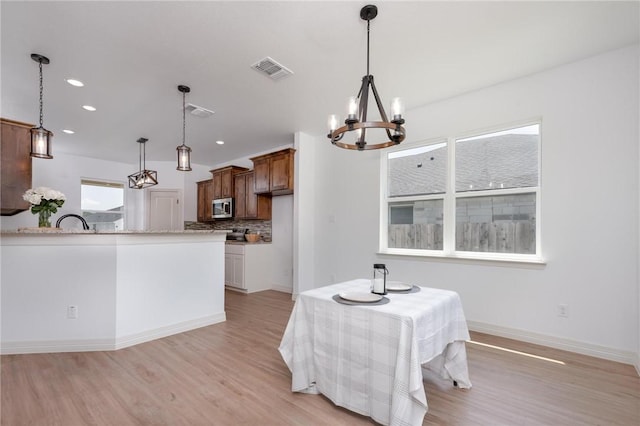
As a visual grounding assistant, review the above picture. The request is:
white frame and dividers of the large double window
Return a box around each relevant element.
[378,118,545,264]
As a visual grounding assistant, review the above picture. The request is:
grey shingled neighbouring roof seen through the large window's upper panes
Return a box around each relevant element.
[388,134,539,197]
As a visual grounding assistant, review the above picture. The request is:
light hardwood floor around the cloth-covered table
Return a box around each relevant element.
[0,291,640,426]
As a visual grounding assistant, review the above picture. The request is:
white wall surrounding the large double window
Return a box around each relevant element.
[299,45,640,363]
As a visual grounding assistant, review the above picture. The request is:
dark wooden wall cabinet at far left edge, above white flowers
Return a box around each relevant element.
[0,118,33,216]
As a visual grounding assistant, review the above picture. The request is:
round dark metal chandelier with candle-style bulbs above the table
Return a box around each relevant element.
[327,5,406,151]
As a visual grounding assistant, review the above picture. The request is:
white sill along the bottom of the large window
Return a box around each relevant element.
[378,249,547,268]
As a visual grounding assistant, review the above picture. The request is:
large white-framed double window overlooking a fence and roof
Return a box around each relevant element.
[381,123,540,261]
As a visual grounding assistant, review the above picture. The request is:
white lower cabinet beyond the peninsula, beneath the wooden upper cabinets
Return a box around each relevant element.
[224,243,273,293]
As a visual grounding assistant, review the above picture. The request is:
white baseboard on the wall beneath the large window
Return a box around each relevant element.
[467,321,640,373]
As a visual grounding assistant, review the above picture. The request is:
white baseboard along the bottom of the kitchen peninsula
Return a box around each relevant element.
[0,312,226,355]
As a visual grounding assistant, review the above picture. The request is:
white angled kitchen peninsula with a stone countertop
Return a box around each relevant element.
[0,229,226,354]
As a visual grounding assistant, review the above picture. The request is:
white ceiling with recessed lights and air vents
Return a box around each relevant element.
[0,0,640,166]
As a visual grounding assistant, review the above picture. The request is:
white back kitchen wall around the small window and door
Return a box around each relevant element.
[0,152,211,230]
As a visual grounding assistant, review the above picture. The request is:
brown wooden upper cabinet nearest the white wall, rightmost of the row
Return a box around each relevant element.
[251,148,296,195]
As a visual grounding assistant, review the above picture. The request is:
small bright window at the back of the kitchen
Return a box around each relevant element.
[80,179,125,231]
